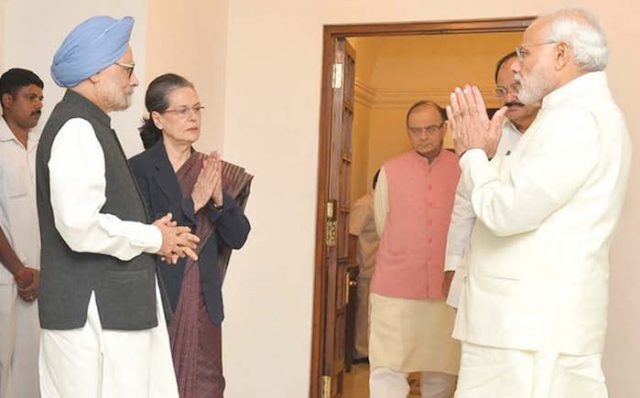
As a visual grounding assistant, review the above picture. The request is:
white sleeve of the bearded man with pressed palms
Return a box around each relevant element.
[460,108,600,236]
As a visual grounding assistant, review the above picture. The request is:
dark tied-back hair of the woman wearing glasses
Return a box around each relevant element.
[138,73,193,149]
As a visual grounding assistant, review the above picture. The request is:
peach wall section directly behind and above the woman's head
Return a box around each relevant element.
[141,0,227,155]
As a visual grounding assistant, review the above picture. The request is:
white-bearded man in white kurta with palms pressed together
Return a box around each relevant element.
[448,9,631,398]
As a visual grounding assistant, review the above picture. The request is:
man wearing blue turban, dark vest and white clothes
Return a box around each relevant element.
[36,16,198,398]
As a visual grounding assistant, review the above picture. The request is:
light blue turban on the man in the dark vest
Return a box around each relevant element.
[51,16,133,87]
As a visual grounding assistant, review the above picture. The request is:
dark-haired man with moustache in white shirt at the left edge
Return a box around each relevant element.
[0,68,44,398]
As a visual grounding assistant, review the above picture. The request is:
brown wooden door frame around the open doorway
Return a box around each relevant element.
[309,16,534,398]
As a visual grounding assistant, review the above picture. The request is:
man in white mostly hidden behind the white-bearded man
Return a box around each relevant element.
[444,51,540,308]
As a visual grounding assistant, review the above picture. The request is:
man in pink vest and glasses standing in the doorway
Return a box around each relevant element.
[369,101,460,398]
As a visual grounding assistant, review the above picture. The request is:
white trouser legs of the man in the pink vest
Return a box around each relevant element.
[369,367,456,398]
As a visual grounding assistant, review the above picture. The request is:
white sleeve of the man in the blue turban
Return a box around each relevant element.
[49,118,162,261]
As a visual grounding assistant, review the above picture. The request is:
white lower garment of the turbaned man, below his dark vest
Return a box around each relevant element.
[40,283,178,398]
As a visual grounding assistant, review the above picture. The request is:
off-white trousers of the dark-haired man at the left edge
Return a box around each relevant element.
[0,282,40,398]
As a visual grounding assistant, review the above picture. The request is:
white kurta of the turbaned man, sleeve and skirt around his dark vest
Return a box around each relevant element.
[40,119,178,398]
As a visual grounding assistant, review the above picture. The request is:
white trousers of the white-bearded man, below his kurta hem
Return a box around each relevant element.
[455,343,608,398]
